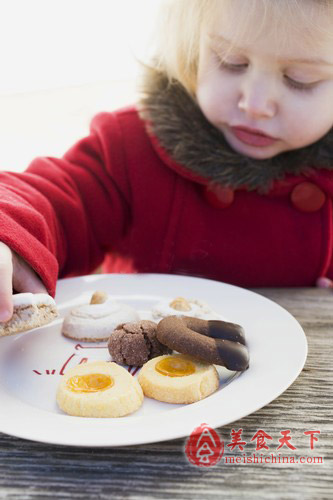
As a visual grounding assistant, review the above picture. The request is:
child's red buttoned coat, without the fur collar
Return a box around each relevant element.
[0,103,333,294]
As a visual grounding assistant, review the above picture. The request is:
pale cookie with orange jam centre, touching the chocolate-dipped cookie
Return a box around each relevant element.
[138,354,219,404]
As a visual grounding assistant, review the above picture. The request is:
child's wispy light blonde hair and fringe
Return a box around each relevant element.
[149,0,333,96]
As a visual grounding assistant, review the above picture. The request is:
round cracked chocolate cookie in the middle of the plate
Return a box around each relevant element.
[108,320,172,366]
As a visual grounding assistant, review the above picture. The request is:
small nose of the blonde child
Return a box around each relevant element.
[238,80,277,119]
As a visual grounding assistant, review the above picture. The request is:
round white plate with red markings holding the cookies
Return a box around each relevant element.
[0,274,307,447]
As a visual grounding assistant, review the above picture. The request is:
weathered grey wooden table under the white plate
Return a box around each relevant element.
[0,288,333,500]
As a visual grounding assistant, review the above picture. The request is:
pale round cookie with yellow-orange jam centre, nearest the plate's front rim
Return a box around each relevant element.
[57,361,143,418]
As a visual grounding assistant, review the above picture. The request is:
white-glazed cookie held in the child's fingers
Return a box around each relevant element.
[0,293,58,337]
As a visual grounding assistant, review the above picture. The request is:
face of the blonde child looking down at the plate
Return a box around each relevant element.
[196,0,333,159]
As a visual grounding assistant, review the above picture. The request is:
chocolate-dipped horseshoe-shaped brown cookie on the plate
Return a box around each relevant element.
[157,316,249,371]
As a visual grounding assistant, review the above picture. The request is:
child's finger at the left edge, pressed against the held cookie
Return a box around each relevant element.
[0,242,13,322]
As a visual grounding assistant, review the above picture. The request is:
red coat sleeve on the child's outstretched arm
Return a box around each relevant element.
[0,113,130,295]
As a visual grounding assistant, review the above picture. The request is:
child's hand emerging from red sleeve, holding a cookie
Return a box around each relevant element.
[0,242,47,321]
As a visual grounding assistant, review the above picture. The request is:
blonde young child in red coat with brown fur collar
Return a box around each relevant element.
[0,0,333,321]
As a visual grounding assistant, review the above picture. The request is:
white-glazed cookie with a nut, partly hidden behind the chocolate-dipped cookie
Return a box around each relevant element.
[152,297,223,319]
